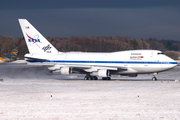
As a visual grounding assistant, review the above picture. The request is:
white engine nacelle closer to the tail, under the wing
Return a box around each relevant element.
[52,67,72,75]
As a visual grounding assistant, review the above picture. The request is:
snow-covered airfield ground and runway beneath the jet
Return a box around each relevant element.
[0,65,180,120]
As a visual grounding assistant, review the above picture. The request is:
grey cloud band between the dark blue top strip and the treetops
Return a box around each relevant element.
[0,7,180,40]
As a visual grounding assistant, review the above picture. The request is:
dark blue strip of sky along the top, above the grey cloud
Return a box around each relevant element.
[0,0,180,10]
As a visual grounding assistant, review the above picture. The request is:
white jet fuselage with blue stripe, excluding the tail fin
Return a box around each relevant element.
[25,50,177,74]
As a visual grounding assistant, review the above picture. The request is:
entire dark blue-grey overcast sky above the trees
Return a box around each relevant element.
[0,0,180,40]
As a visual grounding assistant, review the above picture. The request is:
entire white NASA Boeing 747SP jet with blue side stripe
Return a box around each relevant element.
[19,19,177,80]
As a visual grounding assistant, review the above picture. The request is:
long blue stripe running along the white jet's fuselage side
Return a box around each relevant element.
[26,60,177,64]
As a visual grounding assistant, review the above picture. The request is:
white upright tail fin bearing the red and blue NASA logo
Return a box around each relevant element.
[18,19,58,54]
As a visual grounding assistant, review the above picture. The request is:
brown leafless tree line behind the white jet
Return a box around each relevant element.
[0,36,180,59]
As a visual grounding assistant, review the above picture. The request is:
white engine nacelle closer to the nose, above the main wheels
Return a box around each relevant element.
[91,69,110,77]
